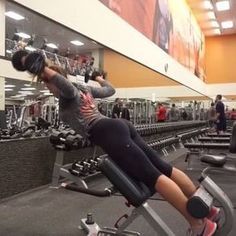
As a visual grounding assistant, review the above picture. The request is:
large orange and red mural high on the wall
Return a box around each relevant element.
[100,0,205,80]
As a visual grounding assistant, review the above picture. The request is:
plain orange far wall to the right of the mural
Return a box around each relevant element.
[205,34,236,86]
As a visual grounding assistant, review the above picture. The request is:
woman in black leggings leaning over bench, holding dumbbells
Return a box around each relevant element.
[12,51,219,236]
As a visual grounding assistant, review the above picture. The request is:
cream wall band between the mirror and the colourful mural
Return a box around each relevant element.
[12,0,206,94]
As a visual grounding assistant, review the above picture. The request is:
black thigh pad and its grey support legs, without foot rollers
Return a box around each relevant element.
[91,156,175,236]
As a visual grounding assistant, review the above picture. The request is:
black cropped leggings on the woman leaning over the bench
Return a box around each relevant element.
[89,118,172,189]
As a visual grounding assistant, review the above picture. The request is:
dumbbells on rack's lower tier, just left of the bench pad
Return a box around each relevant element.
[69,157,99,177]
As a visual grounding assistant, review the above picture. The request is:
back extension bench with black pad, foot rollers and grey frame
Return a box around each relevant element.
[81,156,234,236]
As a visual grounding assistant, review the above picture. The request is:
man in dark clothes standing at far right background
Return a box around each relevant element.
[216,94,226,134]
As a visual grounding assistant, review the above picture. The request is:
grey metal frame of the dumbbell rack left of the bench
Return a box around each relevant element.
[51,145,101,188]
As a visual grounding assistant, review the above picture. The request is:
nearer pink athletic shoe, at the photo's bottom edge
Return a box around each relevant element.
[187,219,217,236]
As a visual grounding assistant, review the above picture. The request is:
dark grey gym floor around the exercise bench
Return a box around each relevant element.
[0,150,236,236]
